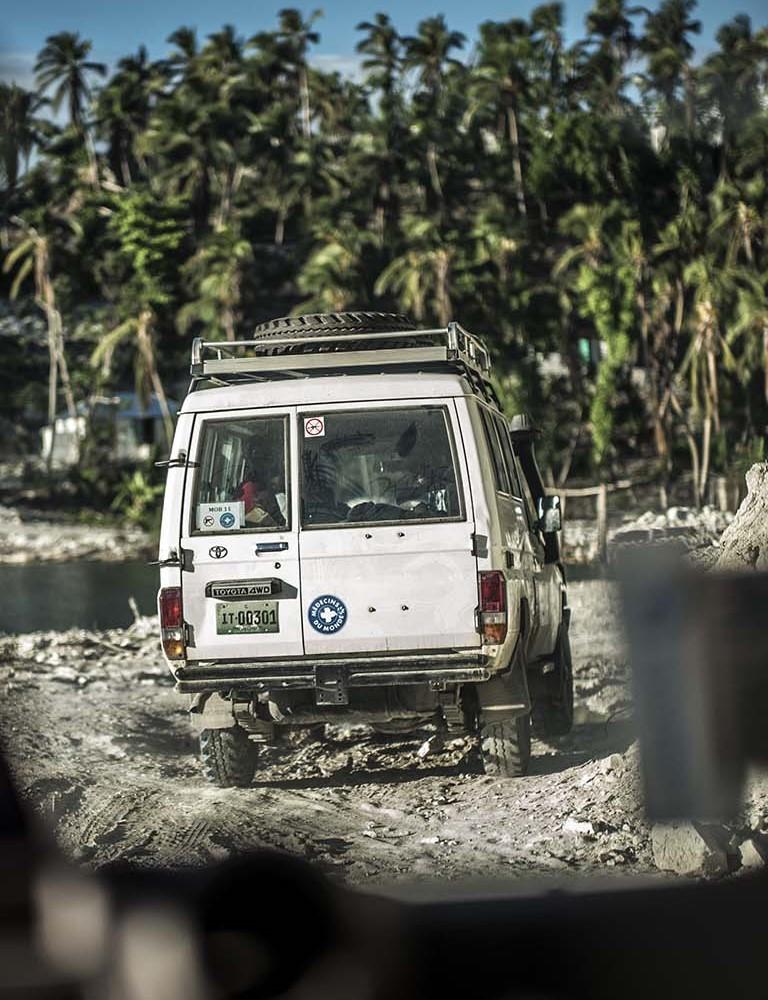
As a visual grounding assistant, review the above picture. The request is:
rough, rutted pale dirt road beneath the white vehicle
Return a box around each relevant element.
[0,581,653,884]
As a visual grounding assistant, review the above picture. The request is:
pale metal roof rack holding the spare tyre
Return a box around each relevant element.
[190,323,491,382]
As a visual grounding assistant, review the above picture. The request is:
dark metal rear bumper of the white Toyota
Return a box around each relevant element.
[174,651,491,694]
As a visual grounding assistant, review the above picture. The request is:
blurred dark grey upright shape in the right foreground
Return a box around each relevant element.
[617,547,768,820]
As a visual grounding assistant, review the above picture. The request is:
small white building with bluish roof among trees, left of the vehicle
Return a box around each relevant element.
[41,391,179,469]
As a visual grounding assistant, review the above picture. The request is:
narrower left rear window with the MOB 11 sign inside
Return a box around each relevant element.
[192,417,290,533]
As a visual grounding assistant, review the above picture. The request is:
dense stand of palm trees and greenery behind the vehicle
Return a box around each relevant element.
[0,0,768,490]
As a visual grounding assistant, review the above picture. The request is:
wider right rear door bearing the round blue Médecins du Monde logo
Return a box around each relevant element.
[297,398,480,655]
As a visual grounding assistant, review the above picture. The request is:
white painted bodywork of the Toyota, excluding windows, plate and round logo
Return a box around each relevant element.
[160,372,564,670]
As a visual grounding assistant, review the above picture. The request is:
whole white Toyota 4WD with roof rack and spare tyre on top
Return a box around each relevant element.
[158,313,573,785]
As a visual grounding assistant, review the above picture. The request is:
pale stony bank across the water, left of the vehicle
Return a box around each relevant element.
[0,506,154,563]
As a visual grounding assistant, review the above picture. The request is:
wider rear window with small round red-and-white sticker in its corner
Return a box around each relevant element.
[299,407,462,527]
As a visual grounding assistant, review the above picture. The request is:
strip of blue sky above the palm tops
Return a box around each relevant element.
[0,0,768,86]
